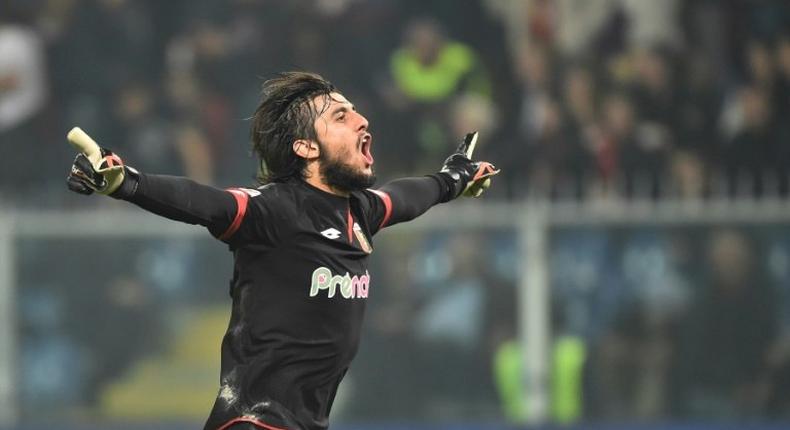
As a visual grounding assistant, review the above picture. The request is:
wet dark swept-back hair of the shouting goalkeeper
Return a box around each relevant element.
[250,72,337,184]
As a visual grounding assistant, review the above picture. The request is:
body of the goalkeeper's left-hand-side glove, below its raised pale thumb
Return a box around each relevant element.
[66,148,137,199]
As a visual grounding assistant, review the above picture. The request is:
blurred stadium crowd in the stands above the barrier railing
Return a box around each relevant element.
[0,0,790,206]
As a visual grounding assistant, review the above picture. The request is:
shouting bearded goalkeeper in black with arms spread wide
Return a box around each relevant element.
[68,72,499,430]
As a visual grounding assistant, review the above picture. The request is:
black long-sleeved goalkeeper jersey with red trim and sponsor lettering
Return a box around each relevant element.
[124,171,454,430]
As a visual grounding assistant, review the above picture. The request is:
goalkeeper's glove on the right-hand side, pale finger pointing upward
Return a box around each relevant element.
[439,133,500,200]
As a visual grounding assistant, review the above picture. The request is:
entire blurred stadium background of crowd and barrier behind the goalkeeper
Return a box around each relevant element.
[0,0,790,430]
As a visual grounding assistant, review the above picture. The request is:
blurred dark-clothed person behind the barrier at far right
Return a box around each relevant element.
[678,230,778,419]
